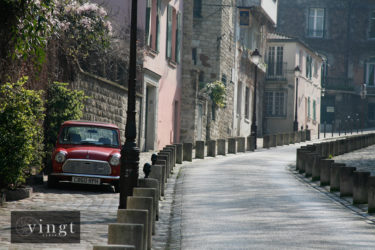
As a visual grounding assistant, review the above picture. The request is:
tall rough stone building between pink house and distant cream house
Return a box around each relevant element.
[181,0,277,145]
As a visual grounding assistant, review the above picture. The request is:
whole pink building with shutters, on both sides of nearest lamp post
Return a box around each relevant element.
[95,0,183,151]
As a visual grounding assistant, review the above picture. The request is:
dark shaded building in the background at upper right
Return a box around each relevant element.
[277,0,375,129]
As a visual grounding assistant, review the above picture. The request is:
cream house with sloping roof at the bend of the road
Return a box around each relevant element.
[263,34,323,136]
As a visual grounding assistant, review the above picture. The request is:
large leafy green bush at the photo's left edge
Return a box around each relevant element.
[0,77,44,188]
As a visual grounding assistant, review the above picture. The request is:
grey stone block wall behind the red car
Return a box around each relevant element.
[70,71,142,143]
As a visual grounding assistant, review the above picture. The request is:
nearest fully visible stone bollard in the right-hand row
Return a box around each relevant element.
[353,171,370,204]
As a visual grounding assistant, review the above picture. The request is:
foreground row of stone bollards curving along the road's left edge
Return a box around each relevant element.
[93,144,183,250]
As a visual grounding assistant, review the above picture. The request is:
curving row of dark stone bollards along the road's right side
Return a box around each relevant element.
[296,134,375,213]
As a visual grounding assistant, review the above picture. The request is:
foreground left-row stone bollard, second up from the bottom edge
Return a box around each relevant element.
[108,223,144,250]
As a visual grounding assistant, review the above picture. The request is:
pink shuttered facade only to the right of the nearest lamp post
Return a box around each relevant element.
[141,0,183,150]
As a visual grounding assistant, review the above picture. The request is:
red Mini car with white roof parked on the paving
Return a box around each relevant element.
[48,121,121,192]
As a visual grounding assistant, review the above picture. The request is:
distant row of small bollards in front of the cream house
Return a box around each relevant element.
[263,130,311,148]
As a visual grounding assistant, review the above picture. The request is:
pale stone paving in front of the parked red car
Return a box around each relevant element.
[0,153,156,250]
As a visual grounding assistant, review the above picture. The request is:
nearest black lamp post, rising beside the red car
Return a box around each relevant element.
[119,0,139,209]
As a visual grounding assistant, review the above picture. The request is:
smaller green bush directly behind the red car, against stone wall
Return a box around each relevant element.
[44,82,88,152]
